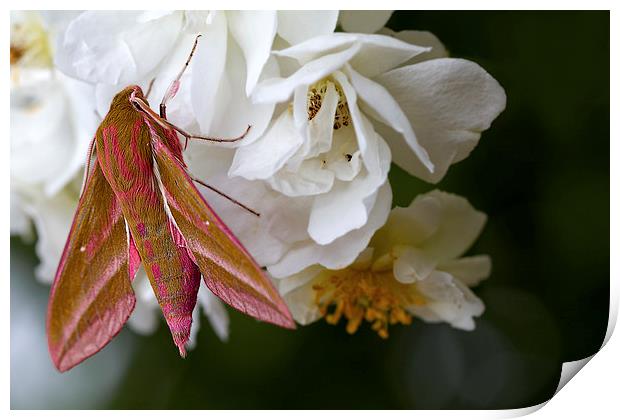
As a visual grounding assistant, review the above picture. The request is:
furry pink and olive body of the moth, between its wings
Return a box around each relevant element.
[97,87,200,354]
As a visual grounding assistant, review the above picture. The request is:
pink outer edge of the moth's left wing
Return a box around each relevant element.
[46,161,140,372]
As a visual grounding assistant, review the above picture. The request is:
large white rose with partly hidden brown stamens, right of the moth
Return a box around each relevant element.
[229,32,505,277]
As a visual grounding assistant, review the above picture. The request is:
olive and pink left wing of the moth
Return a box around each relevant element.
[47,162,140,372]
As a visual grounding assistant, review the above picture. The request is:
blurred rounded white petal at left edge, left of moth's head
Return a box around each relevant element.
[10,69,92,196]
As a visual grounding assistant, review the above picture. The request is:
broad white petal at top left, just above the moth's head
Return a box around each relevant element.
[55,11,183,85]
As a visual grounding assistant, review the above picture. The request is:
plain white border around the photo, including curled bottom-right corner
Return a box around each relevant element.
[0,0,620,420]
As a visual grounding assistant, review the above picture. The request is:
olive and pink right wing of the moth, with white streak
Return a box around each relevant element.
[153,136,295,328]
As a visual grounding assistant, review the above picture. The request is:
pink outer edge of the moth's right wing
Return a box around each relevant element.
[153,137,296,329]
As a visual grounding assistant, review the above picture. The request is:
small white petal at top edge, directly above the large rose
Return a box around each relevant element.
[278,10,338,45]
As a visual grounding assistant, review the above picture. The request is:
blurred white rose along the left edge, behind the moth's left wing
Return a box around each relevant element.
[10,12,97,282]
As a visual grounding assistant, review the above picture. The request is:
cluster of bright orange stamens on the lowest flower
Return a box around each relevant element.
[312,268,425,338]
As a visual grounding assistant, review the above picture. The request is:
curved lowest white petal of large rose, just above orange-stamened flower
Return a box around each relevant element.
[268,182,392,278]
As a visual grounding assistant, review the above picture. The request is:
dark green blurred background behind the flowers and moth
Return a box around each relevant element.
[11,12,610,409]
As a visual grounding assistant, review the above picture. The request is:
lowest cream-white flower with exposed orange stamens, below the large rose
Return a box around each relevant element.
[279,190,491,337]
